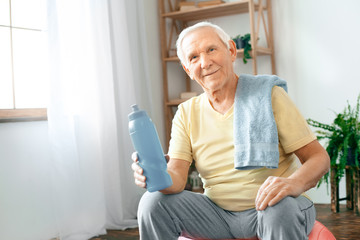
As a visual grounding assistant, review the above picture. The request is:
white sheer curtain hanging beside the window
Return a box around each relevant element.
[48,0,151,240]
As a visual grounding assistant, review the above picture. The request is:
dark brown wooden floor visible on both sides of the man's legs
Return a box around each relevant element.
[92,204,360,240]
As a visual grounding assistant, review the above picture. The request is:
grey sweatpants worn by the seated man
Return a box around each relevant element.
[138,191,316,240]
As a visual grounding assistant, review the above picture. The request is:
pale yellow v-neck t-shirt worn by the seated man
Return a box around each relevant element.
[169,87,316,211]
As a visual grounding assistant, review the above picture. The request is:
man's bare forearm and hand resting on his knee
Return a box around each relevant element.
[255,140,330,210]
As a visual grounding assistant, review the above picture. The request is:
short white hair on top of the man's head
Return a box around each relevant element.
[176,22,231,65]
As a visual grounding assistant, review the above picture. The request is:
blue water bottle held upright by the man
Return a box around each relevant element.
[128,104,172,192]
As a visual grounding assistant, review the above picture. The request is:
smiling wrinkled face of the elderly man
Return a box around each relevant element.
[182,27,236,92]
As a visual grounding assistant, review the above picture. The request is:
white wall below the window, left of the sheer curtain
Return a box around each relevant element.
[0,121,56,240]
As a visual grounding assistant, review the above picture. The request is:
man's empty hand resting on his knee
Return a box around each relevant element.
[255,177,305,211]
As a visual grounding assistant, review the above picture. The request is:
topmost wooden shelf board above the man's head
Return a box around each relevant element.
[162,0,259,21]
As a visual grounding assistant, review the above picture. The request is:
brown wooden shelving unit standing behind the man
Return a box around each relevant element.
[158,0,275,147]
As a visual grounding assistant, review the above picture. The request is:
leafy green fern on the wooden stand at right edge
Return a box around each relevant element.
[307,95,360,187]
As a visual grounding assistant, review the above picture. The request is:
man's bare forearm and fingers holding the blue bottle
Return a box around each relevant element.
[131,152,191,194]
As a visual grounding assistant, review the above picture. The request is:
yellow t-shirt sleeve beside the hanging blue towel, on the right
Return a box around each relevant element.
[271,86,316,153]
